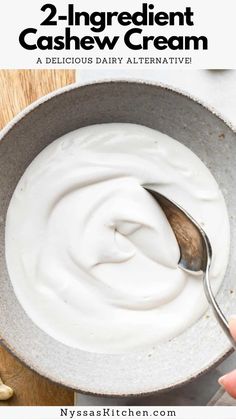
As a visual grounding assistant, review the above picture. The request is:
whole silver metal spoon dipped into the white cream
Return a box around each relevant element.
[145,187,236,349]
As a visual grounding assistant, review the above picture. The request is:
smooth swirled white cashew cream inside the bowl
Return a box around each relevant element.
[6,123,229,353]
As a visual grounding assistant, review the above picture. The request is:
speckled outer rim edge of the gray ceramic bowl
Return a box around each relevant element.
[0,77,236,398]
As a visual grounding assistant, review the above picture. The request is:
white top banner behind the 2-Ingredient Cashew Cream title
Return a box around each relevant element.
[0,0,236,69]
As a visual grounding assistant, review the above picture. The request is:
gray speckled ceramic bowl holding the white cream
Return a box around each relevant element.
[0,81,236,395]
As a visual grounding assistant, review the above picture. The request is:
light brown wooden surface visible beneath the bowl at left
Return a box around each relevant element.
[0,70,75,406]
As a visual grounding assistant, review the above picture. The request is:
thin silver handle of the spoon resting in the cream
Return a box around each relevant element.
[203,266,236,350]
